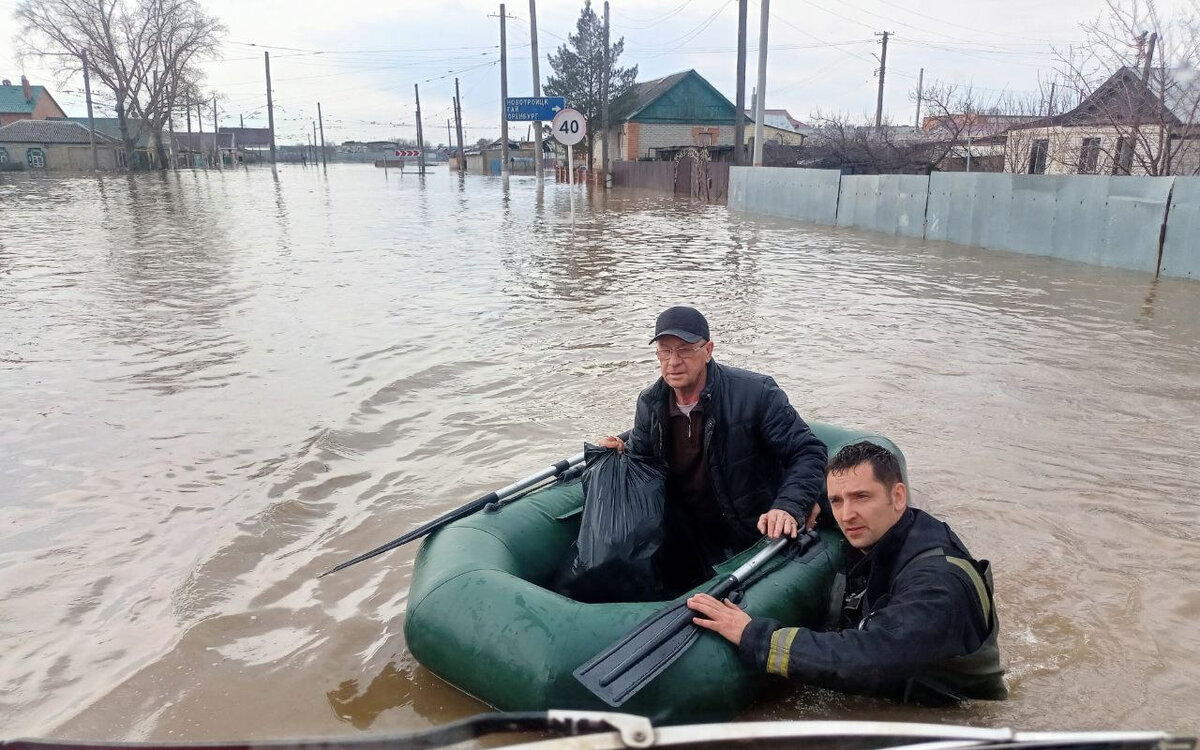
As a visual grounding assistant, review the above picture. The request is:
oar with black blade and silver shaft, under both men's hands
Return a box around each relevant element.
[574,532,818,707]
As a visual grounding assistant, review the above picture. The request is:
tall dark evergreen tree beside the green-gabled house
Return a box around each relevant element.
[545,0,637,168]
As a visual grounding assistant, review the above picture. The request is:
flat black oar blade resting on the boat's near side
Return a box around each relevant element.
[574,600,701,708]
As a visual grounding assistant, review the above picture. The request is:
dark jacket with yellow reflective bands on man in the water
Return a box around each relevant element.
[739,509,1008,704]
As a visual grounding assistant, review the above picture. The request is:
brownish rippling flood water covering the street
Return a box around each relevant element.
[0,166,1200,740]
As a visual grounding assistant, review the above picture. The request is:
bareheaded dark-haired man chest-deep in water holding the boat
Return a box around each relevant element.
[688,442,1008,704]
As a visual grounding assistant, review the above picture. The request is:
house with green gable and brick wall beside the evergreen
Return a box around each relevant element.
[611,70,738,161]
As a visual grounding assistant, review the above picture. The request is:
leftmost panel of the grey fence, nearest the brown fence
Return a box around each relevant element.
[728,167,841,224]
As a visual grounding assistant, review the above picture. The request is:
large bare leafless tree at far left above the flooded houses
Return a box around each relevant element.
[16,0,224,167]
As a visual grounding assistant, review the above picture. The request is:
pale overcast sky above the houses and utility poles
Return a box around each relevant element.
[0,0,1188,144]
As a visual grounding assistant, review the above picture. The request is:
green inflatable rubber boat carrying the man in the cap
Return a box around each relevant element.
[404,424,904,722]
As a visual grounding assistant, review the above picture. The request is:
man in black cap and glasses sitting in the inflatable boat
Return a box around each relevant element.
[600,307,826,588]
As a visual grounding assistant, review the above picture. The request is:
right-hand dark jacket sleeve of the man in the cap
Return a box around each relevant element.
[760,378,827,522]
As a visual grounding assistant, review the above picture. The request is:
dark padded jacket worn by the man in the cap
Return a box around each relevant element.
[629,361,826,548]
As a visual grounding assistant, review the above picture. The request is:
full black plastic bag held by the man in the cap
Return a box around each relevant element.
[556,445,667,602]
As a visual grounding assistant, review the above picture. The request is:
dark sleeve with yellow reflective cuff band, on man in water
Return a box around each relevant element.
[743,560,980,692]
